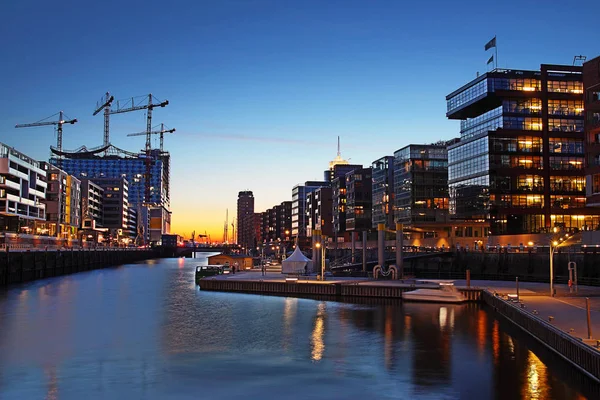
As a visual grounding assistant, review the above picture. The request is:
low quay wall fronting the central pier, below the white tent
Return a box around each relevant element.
[197,278,481,301]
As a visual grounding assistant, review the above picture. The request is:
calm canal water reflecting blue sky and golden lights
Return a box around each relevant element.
[0,259,600,400]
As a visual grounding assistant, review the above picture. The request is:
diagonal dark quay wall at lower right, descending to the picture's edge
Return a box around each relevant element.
[481,290,600,382]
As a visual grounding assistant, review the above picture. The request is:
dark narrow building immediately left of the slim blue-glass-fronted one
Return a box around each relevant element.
[345,168,373,232]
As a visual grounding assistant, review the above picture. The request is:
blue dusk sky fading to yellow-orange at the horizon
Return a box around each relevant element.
[0,0,600,240]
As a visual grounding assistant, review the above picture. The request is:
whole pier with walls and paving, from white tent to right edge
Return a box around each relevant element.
[197,271,600,382]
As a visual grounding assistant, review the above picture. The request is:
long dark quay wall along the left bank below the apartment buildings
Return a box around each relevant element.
[0,249,157,287]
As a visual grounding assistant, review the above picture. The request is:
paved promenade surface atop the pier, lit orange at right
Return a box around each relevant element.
[209,269,600,346]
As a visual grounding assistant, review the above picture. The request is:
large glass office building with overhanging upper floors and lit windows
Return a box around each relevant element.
[446,64,599,235]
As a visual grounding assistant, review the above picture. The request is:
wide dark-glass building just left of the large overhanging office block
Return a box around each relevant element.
[394,142,449,226]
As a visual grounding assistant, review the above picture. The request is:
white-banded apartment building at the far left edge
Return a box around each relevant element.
[0,143,47,234]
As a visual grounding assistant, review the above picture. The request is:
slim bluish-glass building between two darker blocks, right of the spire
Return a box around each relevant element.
[372,156,396,229]
